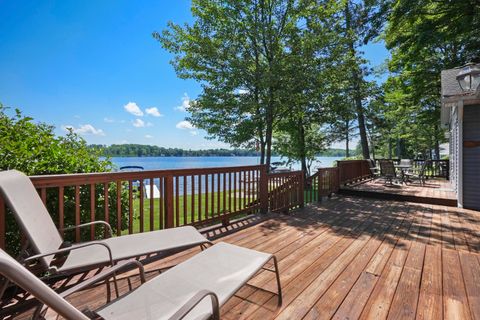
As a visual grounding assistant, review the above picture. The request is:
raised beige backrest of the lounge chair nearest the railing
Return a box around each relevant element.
[0,170,63,268]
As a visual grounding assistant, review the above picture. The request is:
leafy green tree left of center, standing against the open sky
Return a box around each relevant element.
[153,0,310,169]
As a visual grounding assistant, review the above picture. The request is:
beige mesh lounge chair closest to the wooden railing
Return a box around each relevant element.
[0,170,211,275]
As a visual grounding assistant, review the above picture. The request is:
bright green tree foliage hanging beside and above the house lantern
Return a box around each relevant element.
[385,0,480,158]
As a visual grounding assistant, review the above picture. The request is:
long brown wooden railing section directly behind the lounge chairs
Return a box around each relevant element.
[0,166,268,251]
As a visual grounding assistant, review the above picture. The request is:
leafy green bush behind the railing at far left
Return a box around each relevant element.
[0,104,128,253]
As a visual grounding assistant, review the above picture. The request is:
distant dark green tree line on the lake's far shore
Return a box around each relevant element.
[89,144,345,157]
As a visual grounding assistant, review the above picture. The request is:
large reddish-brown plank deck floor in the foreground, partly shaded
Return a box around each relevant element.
[11,196,480,320]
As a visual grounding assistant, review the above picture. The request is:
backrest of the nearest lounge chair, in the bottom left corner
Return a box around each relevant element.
[0,250,89,320]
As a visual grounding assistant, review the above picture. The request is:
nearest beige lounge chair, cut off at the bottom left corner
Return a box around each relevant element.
[0,243,282,320]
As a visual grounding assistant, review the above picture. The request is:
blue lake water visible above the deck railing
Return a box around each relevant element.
[111,157,342,170]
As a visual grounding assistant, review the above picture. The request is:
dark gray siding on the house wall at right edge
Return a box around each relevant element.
[463,105,480,210]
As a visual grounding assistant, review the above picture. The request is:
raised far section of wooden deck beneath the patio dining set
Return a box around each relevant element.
[341,178,457,207]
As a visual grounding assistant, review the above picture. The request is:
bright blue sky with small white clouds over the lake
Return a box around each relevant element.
[0,0,388,149]
